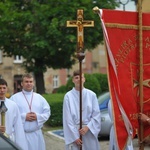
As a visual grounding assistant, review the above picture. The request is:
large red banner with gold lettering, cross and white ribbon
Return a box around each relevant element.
[100,10,150,150]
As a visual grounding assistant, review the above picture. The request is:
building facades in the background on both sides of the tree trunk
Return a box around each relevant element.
[0,45,106,95]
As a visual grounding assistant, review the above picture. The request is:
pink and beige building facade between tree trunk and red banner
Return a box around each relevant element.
[44,45,106,93]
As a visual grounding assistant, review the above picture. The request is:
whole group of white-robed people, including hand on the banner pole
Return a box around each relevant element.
[0,70,150,150]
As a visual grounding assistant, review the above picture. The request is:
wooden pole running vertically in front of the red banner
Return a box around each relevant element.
[138,0,144,150]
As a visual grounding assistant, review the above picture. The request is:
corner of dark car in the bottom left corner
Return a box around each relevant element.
[0,133,22,150]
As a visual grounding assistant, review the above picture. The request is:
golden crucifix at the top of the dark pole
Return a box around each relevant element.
[67,9,94,53]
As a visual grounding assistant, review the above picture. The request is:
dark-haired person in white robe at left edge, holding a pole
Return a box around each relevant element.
[0,79,28,150]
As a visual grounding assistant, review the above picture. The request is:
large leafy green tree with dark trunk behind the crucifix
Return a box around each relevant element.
[0,0,117,94]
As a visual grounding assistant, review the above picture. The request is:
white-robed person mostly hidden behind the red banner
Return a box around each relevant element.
[108,99,133,150]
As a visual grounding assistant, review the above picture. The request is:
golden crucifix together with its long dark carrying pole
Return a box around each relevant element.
[67,9,94,150]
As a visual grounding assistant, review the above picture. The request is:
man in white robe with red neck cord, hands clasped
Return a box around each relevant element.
[11,74,51,150]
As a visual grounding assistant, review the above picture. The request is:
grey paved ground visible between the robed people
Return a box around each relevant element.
[44,132,150,150]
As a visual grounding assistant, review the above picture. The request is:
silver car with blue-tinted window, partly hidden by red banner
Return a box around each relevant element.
[98,92,112,138]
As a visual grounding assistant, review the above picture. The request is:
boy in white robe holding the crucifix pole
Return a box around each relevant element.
[63,70,101,150]
